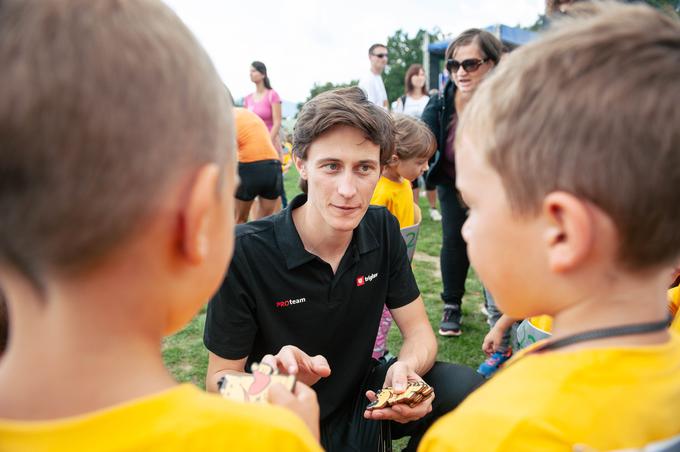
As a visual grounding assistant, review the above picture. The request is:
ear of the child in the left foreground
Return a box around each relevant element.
[180,163,220,264]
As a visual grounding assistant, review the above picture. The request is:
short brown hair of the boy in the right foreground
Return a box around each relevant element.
[457,2,680,269]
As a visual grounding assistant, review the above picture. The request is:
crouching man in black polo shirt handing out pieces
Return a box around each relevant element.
[204,88,481,450]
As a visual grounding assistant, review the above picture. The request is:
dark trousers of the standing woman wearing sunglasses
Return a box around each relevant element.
[437,184,470,306]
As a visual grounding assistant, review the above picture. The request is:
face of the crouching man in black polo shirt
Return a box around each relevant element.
[295,126,380,233]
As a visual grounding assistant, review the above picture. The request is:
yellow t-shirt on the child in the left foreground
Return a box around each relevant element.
[0,384,321,452]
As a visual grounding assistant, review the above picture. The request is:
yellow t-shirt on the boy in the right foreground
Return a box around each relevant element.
[418,333,680,452]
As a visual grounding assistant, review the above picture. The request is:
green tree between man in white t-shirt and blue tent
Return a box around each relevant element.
[383,28,444,102]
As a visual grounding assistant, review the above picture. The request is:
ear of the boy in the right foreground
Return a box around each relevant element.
[542,191,596,273]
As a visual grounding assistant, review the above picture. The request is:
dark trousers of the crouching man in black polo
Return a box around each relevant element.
[321,358,484,452]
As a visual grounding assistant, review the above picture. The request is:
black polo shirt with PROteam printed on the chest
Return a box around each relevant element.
[203,195,420,420]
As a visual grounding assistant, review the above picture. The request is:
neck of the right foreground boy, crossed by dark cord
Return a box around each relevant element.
[553,277,669,349]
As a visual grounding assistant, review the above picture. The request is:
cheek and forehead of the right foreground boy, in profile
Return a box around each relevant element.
[456,135,548,318]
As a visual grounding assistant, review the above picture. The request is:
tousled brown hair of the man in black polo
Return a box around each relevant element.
[293,86,394,193]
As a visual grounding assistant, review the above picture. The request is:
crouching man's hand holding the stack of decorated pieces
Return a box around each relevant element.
[364,361,435,424]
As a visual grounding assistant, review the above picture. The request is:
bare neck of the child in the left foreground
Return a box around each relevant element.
[0,278,176,421]
